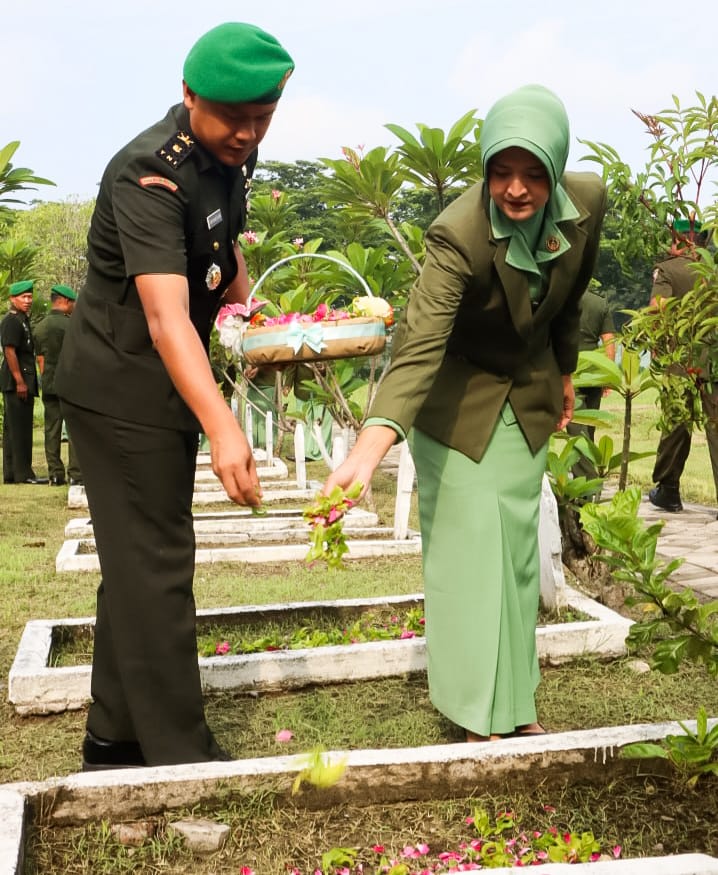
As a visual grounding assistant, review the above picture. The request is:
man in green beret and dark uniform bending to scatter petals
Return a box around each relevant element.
[55,22,294,770]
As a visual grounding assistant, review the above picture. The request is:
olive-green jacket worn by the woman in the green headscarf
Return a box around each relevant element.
[367,173,606,461]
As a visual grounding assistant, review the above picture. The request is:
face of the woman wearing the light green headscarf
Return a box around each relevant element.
[488,146,551,222]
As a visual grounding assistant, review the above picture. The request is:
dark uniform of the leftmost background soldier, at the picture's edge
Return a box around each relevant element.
[0,309,37,483]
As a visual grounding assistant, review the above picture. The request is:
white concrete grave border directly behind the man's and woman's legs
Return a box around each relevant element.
[8,587,631,714]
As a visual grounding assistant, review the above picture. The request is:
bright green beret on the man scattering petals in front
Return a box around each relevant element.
[182,21,294,103]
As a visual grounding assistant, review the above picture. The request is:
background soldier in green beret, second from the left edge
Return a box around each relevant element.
[34,285,82,486]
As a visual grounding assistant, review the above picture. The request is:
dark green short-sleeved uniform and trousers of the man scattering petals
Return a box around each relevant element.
[55,105,256,764]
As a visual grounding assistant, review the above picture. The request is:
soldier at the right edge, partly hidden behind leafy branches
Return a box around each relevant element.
[648,219,718,513]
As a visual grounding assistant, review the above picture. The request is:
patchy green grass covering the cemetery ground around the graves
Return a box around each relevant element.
[0,420,718,875]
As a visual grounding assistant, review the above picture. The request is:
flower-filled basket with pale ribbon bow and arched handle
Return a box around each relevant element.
[216,253,394,365]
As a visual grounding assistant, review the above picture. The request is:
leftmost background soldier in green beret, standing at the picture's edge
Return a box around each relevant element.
[0,280,47,483]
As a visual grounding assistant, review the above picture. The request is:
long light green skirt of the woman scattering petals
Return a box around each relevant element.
[410,404,547,735]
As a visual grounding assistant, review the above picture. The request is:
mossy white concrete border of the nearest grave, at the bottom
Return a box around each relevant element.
[0,718,718,875]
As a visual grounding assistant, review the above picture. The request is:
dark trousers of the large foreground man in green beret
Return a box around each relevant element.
[62,401,220,765]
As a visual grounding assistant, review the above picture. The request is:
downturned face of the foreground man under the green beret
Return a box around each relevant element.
[183,84,277,167]
